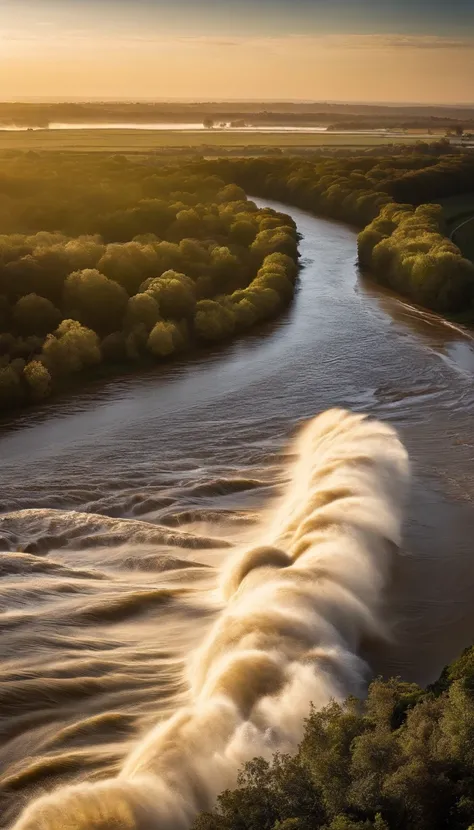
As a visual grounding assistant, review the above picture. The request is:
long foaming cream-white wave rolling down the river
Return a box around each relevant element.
[15,410,408,830]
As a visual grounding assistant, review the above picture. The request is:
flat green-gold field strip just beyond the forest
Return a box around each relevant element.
[0,130,426,153]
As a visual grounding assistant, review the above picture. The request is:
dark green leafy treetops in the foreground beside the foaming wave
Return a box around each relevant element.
[194,648,474,830]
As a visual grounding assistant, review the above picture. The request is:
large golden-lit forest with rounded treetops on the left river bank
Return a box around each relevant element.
[0,154,298,409]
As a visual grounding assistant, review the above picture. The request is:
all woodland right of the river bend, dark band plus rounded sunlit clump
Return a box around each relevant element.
[206,154,474,312]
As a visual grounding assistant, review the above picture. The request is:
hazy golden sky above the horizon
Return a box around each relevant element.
[0,0,474,104]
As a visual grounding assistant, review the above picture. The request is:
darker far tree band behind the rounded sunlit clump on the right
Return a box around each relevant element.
[205,153,474,227]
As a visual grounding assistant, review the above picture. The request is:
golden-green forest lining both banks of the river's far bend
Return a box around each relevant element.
[0,148,474,409]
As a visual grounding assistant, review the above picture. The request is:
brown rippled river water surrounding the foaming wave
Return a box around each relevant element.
[0,205,474,827]
